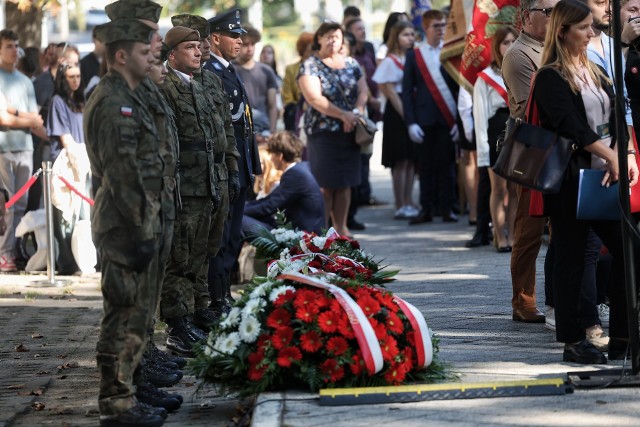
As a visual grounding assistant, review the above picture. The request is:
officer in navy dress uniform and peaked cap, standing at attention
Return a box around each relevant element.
[204,9,262,314]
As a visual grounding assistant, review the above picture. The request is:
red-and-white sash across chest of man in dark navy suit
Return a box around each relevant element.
[414,45,458,127]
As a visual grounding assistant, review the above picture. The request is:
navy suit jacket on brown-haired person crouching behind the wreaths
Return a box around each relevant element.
[244,162,324,233]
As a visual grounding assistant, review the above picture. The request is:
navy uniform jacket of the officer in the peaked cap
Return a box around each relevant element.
[204,55,262,187]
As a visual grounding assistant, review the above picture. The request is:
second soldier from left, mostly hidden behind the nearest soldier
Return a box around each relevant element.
[105,0,186,411]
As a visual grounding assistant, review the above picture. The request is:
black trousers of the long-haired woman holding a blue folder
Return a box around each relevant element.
[551,212,638,343]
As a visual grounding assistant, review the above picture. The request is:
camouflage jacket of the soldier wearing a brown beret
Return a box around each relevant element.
[160,67,220,198]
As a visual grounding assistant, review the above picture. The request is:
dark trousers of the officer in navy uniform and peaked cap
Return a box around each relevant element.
[209,187,248,301]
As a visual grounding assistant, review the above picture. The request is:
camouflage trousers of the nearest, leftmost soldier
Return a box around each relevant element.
[94,228,168,415]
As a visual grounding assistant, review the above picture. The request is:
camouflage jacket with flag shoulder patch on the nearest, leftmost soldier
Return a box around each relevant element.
[83,70,167,240]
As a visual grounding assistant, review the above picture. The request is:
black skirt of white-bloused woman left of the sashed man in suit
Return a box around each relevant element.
[382,101,417,168]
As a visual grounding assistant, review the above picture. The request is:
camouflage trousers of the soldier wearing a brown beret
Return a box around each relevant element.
[160,197,213,319]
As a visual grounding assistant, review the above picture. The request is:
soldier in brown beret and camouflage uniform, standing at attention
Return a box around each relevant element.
[160,26,221,357]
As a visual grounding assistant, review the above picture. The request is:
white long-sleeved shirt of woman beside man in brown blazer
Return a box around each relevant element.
[473,67,507,167]
